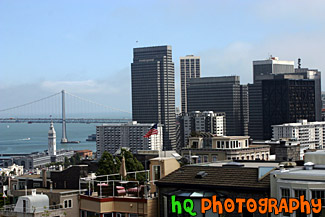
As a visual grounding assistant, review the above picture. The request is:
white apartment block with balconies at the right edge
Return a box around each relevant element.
[272,120,325,155]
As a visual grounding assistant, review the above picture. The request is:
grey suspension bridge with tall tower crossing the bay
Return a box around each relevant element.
[0,90,131,143]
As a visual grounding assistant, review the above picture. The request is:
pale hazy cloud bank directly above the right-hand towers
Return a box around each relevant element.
[198,31,325,89]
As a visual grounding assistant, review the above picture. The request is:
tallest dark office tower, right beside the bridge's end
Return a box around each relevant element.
[131,46,176,150]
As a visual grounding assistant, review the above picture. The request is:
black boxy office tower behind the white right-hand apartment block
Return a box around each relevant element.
[262,77,315,139]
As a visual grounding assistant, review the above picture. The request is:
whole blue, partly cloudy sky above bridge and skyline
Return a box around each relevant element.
[0,0,325,115]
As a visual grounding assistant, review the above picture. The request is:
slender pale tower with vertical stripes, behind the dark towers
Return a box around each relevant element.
[180,55,201,114]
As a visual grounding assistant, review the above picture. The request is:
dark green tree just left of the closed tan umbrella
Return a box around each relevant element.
[96,151,121,175]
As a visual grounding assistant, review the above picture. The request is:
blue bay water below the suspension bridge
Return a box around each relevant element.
[0,123,99,154]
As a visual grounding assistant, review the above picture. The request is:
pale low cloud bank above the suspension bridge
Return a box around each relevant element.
[0,68,131,112]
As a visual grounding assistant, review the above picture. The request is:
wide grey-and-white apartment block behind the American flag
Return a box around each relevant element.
[96,121,163,158]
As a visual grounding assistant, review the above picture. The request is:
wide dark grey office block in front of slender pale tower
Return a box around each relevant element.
[187,76,248,136]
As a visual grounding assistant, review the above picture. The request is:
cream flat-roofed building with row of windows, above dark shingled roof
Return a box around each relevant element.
[181,133,270,163]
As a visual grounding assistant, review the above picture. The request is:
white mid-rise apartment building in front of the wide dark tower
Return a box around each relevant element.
[179,111,226,147]
